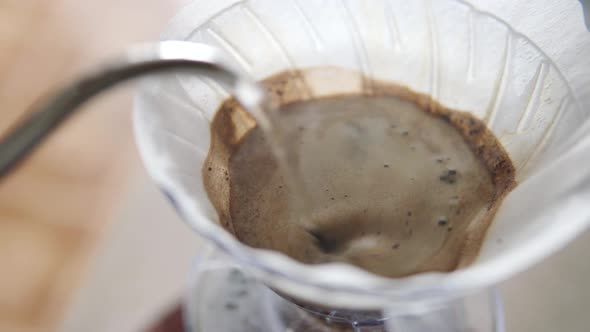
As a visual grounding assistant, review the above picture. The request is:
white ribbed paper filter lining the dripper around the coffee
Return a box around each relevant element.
[135,0,590,303]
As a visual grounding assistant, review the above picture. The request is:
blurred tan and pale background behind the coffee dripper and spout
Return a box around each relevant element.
[0,0,590,332]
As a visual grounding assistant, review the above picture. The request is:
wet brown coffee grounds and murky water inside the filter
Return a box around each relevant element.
[203,68,515,277]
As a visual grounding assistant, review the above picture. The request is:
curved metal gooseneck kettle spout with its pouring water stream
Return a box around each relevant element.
[0,41,314,230]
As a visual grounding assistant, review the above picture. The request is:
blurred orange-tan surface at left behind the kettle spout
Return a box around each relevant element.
[0,0,186,331]
